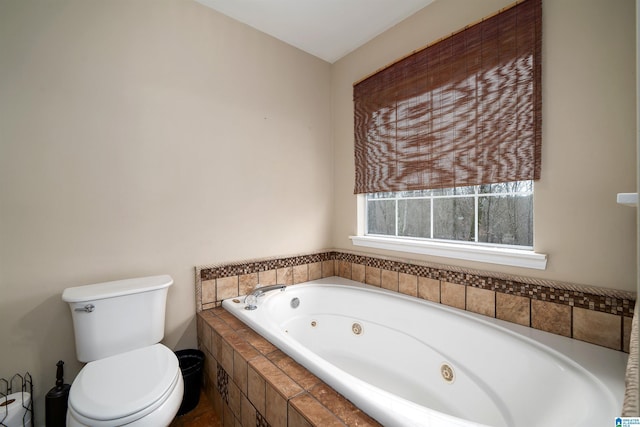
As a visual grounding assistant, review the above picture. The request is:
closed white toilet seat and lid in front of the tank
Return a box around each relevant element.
[68,344,182,426]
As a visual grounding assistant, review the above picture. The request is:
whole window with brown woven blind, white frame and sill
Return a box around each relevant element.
[351,0,546,269]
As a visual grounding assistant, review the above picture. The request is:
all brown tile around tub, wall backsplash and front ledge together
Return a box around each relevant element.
[196,251,638,426]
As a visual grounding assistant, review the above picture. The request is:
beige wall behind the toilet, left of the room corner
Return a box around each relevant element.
[0,0,333,420]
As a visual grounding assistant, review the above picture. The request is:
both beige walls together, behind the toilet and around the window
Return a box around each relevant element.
[0,0,636,420]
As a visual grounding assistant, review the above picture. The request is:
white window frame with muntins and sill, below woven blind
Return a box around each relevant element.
[349,185,547,270]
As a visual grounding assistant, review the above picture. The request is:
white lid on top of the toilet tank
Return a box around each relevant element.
[62,274,173,302]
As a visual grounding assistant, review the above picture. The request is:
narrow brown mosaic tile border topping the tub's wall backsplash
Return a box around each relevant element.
[196,250,636,317]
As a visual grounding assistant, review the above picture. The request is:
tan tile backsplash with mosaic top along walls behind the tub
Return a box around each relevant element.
[196,251,636,352]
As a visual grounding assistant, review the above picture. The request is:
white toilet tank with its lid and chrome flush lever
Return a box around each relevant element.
[62,275,173,362]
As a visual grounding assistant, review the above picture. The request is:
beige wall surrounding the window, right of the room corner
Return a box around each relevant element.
[332,0,636,291]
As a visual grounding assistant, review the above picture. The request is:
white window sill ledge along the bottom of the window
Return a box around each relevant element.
[349,236,547,270]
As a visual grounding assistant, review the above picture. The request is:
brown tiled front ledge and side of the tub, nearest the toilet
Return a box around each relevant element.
[197,308,380,427]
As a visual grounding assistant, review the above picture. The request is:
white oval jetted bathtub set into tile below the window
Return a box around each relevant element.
[222,277,627,427]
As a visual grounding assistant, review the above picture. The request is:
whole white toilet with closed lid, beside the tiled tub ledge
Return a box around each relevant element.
[62,275,184,427]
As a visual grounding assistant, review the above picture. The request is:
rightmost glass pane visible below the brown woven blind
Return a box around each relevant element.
[478,195,533,246]
